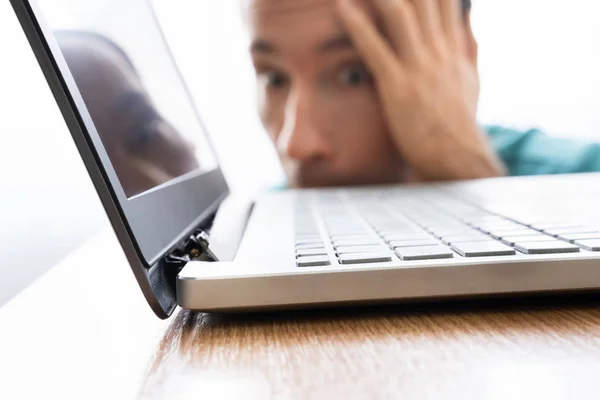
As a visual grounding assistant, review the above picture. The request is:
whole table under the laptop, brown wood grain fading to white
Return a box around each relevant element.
[0,233,600,400]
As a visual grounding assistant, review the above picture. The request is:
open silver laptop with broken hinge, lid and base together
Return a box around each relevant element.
[11,0,600,318]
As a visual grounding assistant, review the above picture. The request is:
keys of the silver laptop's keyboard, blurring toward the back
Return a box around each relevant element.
[295,192,600,267]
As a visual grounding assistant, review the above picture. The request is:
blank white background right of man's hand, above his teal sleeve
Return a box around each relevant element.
[473,0,600,140]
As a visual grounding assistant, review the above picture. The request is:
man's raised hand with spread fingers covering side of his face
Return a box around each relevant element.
[339,0,504,180]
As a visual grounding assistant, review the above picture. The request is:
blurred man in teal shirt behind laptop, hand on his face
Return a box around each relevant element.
[246,0,600,187]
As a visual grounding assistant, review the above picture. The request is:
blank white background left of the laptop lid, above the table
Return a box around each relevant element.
[0,1,106,305]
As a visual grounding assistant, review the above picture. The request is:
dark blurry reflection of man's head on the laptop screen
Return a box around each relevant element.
[57,32,199,197]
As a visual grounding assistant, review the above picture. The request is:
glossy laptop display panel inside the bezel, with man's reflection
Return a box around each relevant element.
[39,0,217,198]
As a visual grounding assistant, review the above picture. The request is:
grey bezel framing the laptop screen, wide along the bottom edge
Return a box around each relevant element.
[18,0,229,265]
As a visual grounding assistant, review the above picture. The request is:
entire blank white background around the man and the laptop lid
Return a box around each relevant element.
[0,0,600,304]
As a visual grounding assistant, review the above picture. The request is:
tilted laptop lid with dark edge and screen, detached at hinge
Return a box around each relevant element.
[11,0,228,318]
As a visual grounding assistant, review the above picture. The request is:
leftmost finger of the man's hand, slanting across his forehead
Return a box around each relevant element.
[338,0,399,79]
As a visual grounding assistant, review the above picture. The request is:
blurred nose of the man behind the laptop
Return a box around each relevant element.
[277,88,332,161]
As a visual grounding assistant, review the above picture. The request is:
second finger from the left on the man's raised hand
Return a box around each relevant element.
[374,0,424,63]
